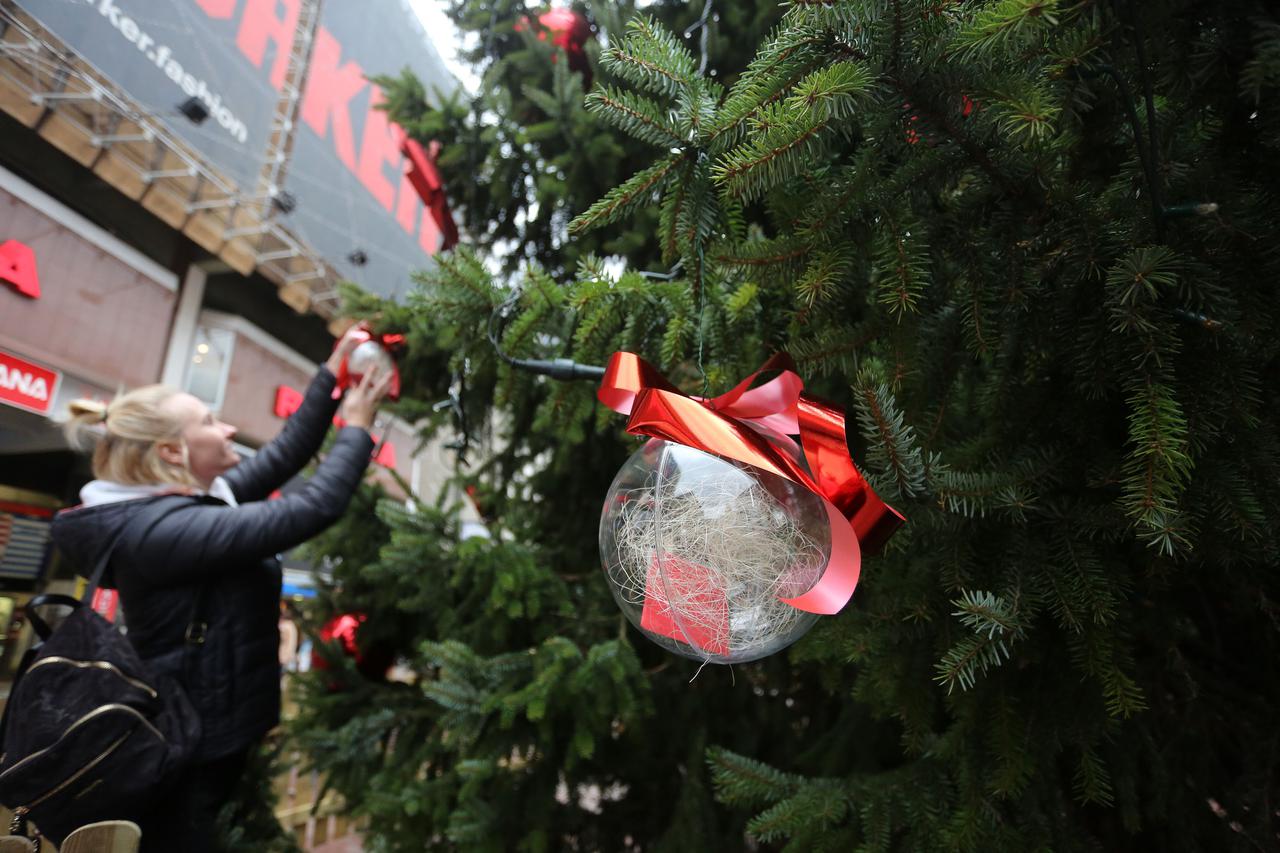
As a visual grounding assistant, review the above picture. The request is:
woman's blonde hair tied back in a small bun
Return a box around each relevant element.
[64,386,198,487]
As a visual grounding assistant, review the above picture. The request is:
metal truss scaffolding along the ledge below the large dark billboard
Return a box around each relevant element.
[0,0,339,319]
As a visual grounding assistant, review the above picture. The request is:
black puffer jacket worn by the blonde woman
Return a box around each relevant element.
[52,368,372,761]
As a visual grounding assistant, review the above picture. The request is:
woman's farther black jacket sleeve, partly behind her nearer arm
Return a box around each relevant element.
[223,366,338,503]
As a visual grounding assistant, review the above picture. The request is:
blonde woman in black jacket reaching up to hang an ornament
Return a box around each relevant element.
[52,334,390,850]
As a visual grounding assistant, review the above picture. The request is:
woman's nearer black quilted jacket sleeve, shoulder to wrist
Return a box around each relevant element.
[122,427,374,585]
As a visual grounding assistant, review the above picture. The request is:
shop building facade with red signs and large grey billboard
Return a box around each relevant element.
[0,0,471,693]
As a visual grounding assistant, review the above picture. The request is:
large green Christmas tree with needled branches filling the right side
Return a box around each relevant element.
[293,0,1280,852]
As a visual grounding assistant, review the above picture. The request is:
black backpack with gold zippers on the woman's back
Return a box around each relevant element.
[0,532,204,844]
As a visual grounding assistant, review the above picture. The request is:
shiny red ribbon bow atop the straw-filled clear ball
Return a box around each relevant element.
[596,352,905,615]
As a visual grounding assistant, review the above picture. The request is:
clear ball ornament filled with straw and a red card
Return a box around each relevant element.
[600,435,831,663]
